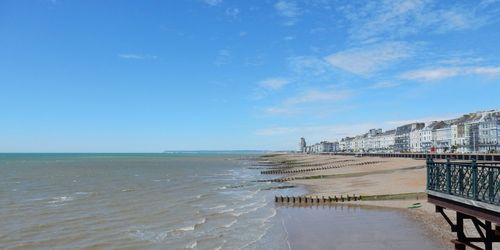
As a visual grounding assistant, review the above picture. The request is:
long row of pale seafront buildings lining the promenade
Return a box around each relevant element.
[300,110,500,153]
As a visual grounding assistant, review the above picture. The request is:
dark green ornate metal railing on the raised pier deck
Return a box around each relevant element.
[427,158,500,205]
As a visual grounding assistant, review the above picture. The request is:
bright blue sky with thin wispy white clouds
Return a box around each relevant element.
[0,0,500,152]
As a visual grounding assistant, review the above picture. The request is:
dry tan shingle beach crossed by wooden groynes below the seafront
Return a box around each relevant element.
[264,154,499,249]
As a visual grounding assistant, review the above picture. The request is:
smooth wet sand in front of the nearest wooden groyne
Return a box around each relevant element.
[278,205,451,249]
